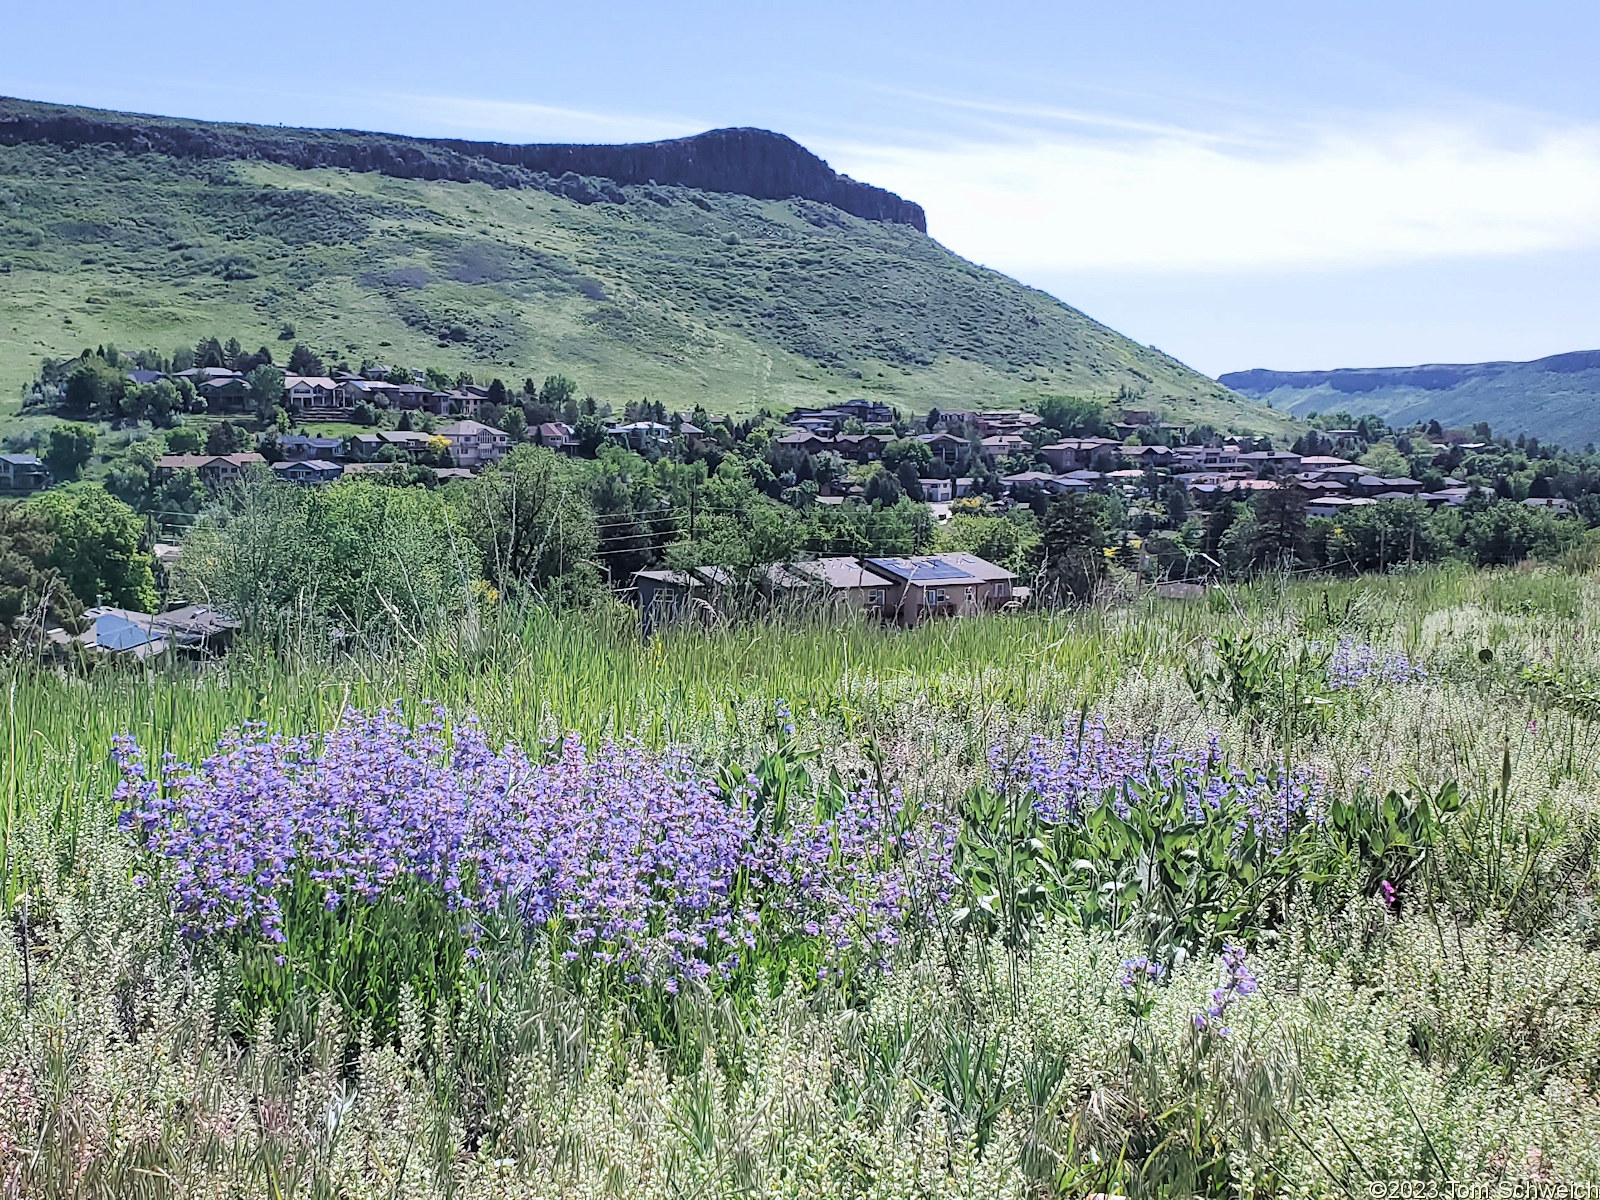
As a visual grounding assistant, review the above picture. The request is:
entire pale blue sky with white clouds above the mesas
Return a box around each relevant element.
[0,0,1600,374]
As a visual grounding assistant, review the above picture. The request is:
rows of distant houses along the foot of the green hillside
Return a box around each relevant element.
[18,347,1573,518]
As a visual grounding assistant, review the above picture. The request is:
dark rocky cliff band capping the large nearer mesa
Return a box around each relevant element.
[0,98,928,232]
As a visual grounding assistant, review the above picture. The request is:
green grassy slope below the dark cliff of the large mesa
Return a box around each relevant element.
[0,125,1286,432]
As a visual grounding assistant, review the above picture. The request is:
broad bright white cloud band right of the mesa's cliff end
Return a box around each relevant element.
[827,115,1600,274]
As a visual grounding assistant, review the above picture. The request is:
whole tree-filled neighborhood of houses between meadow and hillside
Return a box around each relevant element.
[9,339,1600,668]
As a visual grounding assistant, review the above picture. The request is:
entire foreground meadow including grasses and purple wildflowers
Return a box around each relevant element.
[0,562,1600,1200]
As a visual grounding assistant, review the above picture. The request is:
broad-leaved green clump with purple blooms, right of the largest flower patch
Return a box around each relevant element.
[955,725,1318,965]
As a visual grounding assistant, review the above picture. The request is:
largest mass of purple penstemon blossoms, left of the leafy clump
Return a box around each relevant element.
[115,706,954,979]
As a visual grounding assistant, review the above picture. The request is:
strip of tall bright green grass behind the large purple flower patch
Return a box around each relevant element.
[0,602,1211,838]
